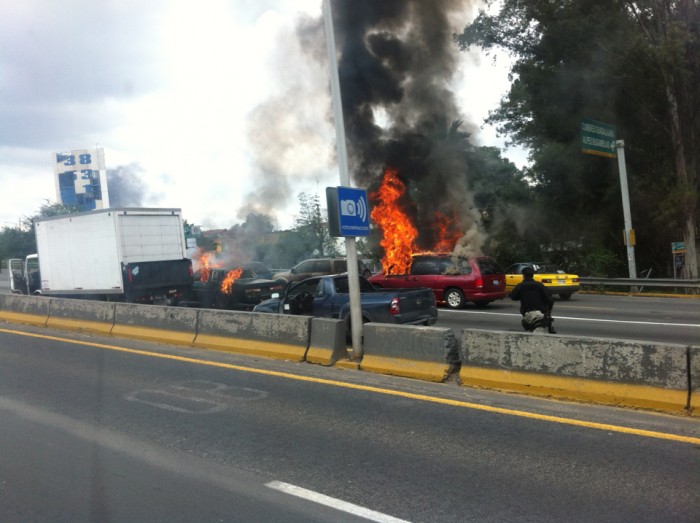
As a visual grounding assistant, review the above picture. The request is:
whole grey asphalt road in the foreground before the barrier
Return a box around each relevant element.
[0,323,700,522]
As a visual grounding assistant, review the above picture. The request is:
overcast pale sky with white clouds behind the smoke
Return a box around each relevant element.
[0,0,523,228]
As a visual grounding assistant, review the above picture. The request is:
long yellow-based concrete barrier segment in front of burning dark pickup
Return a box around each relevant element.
[194,309,311,361]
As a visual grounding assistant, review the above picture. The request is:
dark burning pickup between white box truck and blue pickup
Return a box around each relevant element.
[192,263,287,310]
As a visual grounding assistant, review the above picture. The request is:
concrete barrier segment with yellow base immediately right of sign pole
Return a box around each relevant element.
[360,323,459,382]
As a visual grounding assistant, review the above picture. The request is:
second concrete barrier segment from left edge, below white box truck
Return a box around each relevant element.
[44,298,116,334]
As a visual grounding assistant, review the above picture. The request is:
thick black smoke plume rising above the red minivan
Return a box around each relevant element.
[332,0,483,254]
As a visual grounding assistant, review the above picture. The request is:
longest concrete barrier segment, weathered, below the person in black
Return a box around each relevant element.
[460,330,688,412]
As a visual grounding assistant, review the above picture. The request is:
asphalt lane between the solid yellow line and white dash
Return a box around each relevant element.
[2,328,699,521]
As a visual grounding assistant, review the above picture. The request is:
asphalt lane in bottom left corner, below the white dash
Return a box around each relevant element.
[0,397,378,522]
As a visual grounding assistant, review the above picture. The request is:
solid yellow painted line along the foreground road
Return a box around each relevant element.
[0,328,700,445]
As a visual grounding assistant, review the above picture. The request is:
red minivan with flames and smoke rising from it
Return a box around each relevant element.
[369,254,507,309]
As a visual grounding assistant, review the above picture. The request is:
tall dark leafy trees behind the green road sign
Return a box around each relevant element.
[456,0,700,274]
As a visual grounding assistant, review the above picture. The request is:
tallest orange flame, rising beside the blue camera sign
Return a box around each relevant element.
[370,169,418,274]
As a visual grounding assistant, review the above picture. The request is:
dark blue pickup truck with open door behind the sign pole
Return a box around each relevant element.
[253,274,437,330]
